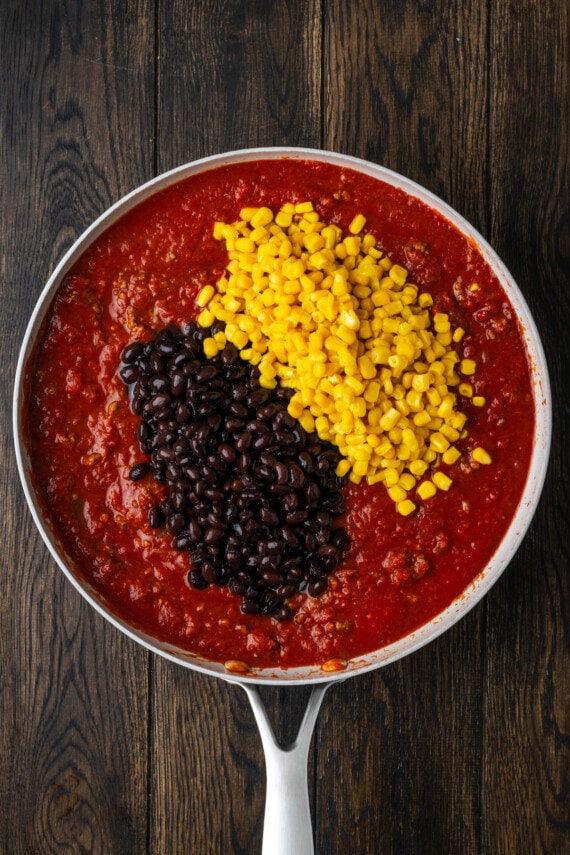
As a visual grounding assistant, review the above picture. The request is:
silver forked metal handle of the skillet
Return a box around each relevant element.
[240,683,330,855]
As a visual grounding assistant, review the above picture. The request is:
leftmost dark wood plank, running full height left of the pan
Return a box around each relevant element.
[0,2,153,855]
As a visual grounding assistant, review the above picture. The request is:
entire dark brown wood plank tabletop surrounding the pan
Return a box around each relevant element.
[0,0,570,855]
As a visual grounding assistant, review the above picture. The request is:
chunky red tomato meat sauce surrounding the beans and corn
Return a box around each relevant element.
[26,160,534,667]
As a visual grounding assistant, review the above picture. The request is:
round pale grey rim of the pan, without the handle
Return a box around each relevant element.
[13,146,552,685]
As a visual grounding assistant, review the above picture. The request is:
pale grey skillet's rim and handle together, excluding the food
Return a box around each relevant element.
[13,147,552,855]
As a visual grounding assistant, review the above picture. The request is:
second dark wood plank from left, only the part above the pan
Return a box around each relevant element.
[158,0,322,171]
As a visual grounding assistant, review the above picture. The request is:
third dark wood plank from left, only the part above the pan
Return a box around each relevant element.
[323,0,489,228]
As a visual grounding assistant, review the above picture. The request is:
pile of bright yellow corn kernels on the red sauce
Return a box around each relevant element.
[197,201,490,515]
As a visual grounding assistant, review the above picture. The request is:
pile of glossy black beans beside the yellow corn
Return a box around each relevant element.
[119,324,348,620]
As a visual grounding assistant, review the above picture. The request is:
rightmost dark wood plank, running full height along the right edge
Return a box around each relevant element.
[483,2,570,855]
